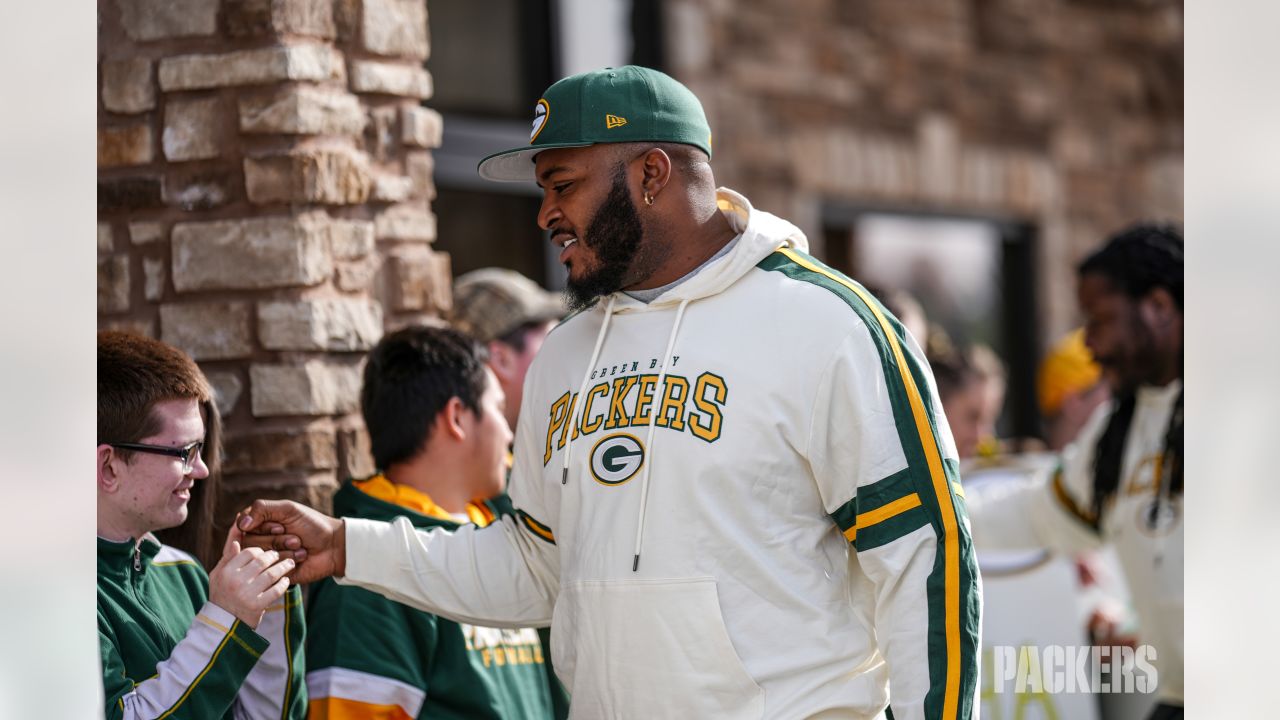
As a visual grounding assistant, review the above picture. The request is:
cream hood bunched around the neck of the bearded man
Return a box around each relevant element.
[604,187,809,313]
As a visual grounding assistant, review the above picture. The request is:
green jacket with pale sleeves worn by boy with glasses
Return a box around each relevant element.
[97,534,306,720]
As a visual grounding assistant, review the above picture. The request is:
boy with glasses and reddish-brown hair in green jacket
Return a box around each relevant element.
[96,332,306,720]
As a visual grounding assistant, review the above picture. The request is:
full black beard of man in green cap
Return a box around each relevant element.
[564,165,644,313]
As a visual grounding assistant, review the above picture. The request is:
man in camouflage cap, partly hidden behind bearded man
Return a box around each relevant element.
[449,268,564,428]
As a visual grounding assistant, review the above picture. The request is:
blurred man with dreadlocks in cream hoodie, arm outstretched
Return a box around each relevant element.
[969,224,1183,720]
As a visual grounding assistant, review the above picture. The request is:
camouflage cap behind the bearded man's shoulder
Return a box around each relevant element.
[449,268,566,342]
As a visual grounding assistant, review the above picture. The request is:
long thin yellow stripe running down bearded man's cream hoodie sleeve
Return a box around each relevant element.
[778,247,960,717]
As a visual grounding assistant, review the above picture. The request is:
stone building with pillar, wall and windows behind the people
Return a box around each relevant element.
[85,0,1184,716]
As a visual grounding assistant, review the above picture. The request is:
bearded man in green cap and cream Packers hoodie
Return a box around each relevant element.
[239,67,980,720]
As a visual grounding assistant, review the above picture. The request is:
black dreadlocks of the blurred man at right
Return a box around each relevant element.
[1076,224,1183,521]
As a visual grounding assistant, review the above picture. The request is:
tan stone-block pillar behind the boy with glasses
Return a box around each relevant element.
[97,0,451,524]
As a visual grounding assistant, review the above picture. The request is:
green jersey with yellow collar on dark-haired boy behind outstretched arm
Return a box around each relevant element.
[307,475,567,720]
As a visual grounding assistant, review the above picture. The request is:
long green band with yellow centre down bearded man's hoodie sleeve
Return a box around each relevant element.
[756,247,980,717]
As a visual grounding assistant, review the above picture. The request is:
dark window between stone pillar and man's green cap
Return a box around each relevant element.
[426,0,662,290]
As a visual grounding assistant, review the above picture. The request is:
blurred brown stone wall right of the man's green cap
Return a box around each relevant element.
[666,0,1183,343]
